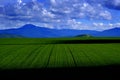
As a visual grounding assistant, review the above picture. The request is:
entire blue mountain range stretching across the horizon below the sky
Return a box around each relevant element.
[0,24,120,38]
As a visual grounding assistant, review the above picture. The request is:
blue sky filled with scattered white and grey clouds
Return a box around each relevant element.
[0,0,120,31]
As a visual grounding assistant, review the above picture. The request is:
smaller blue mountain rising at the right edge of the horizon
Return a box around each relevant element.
[94,28,120,37]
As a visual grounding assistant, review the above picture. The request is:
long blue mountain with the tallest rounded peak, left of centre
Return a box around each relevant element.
[0,24,97,38]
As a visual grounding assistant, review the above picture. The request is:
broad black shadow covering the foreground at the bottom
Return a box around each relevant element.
[0,65,120,80]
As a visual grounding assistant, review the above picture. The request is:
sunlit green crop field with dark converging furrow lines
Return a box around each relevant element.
[0,38,120,69]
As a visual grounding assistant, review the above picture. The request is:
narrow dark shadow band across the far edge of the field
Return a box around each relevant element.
[0,39,120,45]
